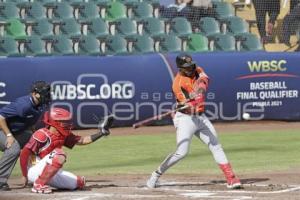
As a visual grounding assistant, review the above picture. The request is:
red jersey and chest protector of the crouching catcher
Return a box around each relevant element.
[25,128,81,158]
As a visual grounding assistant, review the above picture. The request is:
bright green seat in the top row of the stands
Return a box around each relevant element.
[105,2,127,21]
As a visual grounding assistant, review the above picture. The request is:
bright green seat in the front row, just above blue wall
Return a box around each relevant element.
[185,33,209,52]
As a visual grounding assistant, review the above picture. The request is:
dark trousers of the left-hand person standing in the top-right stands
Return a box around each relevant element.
[253,0,280,38]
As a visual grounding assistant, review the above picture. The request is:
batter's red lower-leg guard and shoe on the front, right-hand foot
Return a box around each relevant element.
[219,163,242,189]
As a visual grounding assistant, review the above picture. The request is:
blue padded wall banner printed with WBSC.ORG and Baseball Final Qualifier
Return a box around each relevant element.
[0,52,300,128]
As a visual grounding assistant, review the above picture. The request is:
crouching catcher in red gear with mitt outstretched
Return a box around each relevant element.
[20,107,114,194]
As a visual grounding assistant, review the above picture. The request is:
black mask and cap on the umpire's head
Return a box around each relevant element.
[31,81,51,105]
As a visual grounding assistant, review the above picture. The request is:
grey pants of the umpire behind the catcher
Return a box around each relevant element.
[0,131,32,183]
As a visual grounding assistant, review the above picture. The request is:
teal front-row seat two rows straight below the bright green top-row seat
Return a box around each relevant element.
[104,35,129,55]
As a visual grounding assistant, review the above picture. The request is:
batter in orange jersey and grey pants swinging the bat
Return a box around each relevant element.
[147,54,241,189]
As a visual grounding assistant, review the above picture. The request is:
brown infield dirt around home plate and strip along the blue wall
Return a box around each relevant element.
[0,121,300,200]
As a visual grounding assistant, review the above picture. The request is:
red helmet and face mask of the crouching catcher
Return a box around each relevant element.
[43,107,72,136]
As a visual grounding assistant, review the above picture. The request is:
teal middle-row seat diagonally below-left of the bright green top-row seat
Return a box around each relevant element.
[80,18,109,37]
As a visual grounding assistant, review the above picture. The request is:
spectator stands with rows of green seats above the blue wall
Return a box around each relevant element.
[0,0,300,56]
